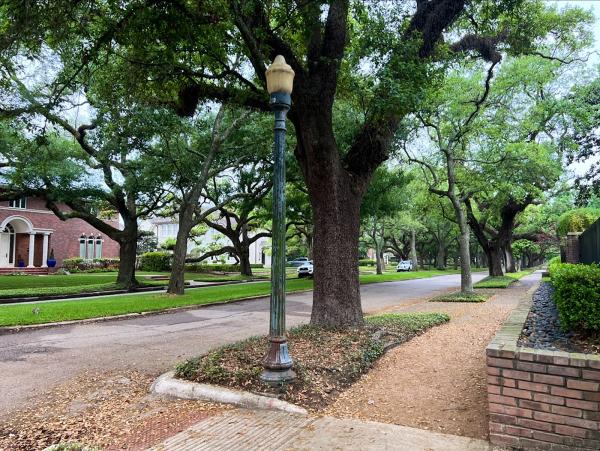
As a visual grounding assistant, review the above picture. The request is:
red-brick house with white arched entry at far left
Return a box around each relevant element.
[0,197,119,273]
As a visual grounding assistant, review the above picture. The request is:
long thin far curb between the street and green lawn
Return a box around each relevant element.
[0,290,312,336]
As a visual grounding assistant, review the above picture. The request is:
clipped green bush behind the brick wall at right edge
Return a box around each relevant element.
[550,263,600,332]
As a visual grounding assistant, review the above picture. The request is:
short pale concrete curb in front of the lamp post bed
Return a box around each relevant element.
[150,371,308,415]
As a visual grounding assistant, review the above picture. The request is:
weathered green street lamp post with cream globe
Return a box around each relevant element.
[260,55,296,385]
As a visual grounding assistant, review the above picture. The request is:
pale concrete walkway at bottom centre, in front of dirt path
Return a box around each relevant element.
[151,409,499,451]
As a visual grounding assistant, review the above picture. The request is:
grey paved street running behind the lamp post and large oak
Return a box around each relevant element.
[0,273,484,417]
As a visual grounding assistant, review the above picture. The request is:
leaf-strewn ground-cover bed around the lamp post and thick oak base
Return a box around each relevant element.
[176,313,449,411]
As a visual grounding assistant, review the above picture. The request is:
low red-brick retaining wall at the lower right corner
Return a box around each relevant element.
[486,287,600,450]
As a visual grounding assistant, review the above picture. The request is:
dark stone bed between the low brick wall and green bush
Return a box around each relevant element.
[519,282,600,354]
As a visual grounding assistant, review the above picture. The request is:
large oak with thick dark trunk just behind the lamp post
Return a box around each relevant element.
[0,0,592,326]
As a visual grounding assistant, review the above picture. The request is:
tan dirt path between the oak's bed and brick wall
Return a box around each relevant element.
[324,275,539,438]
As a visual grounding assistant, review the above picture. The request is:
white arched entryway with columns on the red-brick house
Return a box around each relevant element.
[0,215,51,268]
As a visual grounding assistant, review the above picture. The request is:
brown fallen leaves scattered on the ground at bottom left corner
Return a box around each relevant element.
[0,371,226,451]
